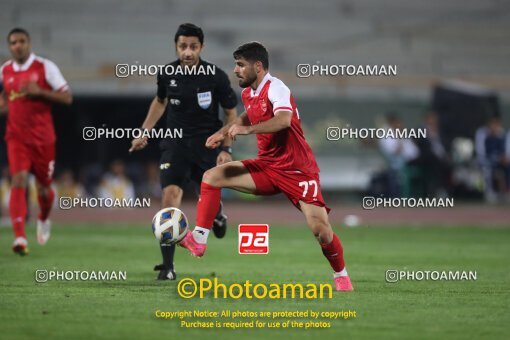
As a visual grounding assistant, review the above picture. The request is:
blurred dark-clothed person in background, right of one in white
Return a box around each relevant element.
[415,111,452,197]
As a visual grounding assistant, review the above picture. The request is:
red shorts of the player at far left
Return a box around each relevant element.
[7,139,55,186]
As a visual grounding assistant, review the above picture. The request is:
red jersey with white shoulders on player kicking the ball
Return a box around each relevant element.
[241,73,319,174]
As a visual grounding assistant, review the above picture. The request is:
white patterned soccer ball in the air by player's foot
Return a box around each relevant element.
[152,208,189,244]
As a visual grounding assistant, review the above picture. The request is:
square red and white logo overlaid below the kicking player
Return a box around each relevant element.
[238,224,269,254]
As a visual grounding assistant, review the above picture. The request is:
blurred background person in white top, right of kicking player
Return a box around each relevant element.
[379,113,420,197]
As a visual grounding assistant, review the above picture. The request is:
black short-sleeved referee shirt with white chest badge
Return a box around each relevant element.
[157,59,237,138]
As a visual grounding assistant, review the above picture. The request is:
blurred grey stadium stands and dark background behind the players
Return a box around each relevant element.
[0,0,510,224]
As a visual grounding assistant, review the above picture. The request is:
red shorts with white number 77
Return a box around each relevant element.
[241,159,331,213]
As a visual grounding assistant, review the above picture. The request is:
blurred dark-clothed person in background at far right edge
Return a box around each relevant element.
[475,116,510,202]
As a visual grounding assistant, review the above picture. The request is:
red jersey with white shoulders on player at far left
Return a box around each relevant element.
[0,53,68,145]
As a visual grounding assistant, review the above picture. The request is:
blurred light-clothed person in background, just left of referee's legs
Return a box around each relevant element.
[98,160,136,199]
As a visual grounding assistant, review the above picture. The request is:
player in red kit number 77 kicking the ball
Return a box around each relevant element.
[180,42,353,291]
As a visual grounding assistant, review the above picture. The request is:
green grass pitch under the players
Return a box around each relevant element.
[0,224,510,339]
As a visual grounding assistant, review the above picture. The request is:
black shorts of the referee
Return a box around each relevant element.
[159,136,220,188]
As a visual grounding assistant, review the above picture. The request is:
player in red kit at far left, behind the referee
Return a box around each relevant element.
[0,28,73,255]
